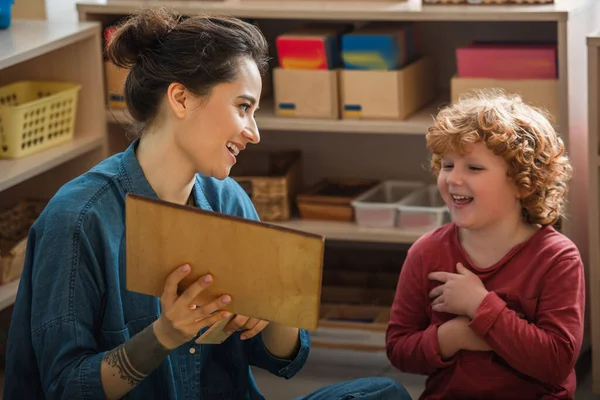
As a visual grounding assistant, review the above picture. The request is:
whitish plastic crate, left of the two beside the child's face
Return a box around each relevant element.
[351,181,425,228]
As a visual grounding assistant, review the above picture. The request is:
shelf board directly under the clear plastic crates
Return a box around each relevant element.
[269,219,425,244]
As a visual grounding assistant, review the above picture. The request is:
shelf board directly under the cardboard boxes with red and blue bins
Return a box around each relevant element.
[106,96,448,135]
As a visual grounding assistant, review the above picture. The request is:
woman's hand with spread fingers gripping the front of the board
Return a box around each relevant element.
[153,265,231,349]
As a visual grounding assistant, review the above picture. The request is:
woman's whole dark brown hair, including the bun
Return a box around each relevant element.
[106,8,268,134]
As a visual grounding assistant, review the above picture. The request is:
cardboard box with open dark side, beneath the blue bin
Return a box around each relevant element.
[340,58,436,119]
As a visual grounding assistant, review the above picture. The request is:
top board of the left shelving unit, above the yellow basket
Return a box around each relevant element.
[0,20,100,69]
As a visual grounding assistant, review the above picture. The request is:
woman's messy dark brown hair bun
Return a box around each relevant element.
[106,8,179,68]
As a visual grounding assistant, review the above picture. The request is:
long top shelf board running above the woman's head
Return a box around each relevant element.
[77,0,580,21]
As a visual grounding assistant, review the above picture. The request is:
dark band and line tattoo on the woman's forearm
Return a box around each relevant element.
[104,325,170,386]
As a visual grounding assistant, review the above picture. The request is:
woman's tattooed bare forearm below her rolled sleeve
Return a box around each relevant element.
[100,324,171,399]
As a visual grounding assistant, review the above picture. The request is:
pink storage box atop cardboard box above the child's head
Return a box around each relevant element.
[456,43,558,79]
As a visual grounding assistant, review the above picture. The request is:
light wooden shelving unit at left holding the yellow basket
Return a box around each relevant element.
[0,20,106,310]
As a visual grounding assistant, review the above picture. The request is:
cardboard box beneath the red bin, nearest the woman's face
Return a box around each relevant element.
[273,68,339,119]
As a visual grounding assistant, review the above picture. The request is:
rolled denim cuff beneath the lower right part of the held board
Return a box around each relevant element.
[247,329,310,379]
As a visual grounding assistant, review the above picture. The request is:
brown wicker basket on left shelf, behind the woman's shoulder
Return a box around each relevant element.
[0,200,47,285]
